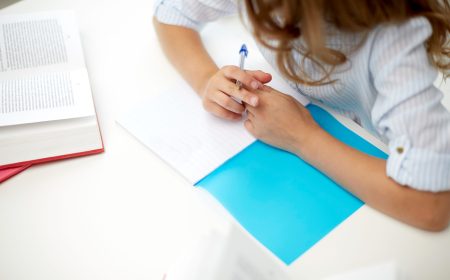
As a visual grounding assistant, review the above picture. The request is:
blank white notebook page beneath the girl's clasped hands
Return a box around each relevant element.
[118,86,255,184]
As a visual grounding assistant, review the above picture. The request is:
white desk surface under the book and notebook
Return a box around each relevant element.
[0,0,450,280]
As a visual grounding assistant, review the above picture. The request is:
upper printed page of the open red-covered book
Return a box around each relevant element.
[0,12,85,73]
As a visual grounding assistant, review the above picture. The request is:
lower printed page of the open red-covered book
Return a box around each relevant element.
[0,70,95,126]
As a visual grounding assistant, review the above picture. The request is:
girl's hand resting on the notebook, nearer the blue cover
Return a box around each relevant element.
[244,86,321,155]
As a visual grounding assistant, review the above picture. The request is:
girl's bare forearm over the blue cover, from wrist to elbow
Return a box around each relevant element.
[296,129,450,231]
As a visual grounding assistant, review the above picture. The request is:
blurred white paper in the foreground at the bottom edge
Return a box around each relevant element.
[166,221,291,280]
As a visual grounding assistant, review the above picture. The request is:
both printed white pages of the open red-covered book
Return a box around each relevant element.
[0,12,95,126]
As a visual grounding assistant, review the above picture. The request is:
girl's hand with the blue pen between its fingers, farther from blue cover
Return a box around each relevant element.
[200,66,272,120]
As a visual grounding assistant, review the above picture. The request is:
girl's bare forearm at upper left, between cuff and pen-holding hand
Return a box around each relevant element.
[153,18,218,95]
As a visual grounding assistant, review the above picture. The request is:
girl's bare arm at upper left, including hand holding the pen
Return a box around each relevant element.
[153,18,272,120]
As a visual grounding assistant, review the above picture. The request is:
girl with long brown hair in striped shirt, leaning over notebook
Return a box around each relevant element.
[154,0,450,231]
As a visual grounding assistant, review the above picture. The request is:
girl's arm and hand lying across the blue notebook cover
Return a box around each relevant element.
[245,87,450,231]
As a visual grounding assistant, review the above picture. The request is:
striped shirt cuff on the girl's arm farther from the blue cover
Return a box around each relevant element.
[154,0,202,31]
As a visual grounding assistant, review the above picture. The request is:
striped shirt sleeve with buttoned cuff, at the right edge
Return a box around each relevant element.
[369,17,450,192]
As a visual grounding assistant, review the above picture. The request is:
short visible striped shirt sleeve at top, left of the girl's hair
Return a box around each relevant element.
[154,0,237,31]
